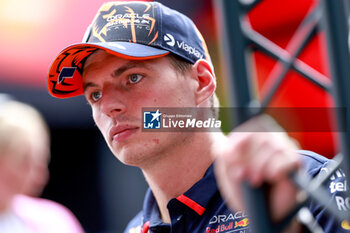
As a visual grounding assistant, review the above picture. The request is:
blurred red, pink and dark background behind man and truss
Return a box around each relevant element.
[0,0,337,233]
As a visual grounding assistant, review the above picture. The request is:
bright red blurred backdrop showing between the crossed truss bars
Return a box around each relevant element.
[249,0,338,158]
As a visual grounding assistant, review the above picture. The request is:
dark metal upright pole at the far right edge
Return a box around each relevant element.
[321,0,350,213]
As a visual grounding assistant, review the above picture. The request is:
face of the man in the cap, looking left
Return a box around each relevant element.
[83,50,198,166]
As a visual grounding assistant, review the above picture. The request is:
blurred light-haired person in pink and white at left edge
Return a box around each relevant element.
[0,96,83,233]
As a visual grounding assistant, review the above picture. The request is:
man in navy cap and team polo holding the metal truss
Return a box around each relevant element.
[48,2,348,233]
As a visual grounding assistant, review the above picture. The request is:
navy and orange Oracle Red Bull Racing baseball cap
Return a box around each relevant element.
[47,1,211,98]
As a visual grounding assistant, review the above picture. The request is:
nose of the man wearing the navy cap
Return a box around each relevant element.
[101,86,126,118]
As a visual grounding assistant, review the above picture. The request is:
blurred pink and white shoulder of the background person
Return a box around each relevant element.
[13,195,84,233]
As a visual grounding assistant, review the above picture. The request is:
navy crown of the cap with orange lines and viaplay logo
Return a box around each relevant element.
[86,2,206,64]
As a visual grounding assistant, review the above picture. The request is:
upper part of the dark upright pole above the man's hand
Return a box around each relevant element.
[216,0,253,126]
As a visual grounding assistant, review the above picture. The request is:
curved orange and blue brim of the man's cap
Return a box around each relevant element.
[47,42,169,98]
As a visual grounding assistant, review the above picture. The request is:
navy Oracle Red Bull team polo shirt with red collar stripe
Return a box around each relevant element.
[124,151,350,233]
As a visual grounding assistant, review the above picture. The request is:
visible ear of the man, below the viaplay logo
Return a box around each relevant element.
[193,59,216,105]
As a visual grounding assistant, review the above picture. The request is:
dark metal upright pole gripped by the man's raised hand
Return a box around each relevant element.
[216,0,273,233]
